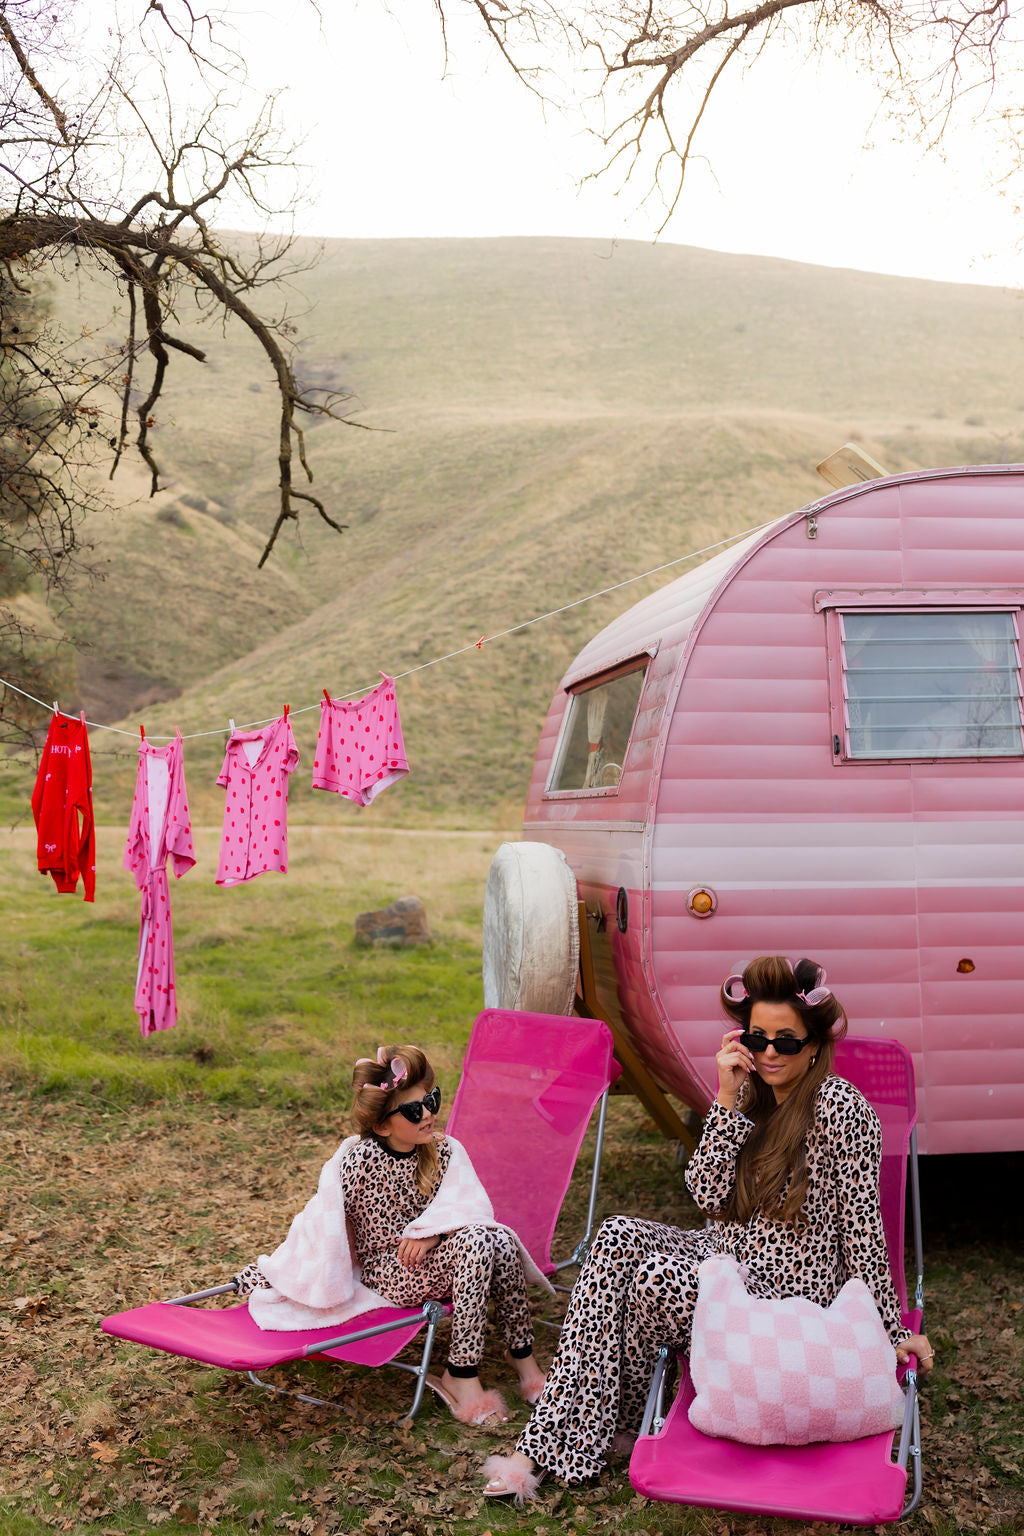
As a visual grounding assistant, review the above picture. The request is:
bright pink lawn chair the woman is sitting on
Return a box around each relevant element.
[629,1040,924,1525]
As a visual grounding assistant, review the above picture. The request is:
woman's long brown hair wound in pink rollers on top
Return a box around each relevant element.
[718,955,847,1223]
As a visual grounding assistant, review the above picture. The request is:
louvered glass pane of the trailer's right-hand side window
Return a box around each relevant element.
[840,610,1024,757]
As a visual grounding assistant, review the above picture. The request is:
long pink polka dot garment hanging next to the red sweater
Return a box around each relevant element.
[124,731,195,1037]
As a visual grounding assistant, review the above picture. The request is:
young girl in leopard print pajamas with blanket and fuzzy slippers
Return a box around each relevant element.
[235,1046,547,1424]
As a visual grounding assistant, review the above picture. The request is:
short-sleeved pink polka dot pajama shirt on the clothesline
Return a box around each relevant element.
[216,714,299,885]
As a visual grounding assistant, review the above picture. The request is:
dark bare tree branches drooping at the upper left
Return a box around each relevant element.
[0,0,356,592]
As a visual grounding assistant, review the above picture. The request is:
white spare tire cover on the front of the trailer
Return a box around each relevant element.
[484,843,579,1014]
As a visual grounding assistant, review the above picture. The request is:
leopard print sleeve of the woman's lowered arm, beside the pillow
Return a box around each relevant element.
[817,1077,910,1346]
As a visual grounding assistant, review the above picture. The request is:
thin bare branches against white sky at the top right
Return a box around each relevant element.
[454,0,1018,233]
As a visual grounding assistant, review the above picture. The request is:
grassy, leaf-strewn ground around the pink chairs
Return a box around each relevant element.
[0,829,1024,1536]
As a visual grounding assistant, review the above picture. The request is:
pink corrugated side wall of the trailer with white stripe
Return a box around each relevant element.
[640,472,1024,1152]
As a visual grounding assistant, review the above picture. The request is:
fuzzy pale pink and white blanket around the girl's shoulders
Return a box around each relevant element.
[249,1137,553,1332]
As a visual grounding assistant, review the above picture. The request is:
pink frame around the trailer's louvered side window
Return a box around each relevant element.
[814,587,1024,766]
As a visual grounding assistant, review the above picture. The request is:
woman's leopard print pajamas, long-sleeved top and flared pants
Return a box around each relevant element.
[516,1077,910,1482]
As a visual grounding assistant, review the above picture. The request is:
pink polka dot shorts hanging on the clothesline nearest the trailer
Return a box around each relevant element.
[313,673,408,805]
